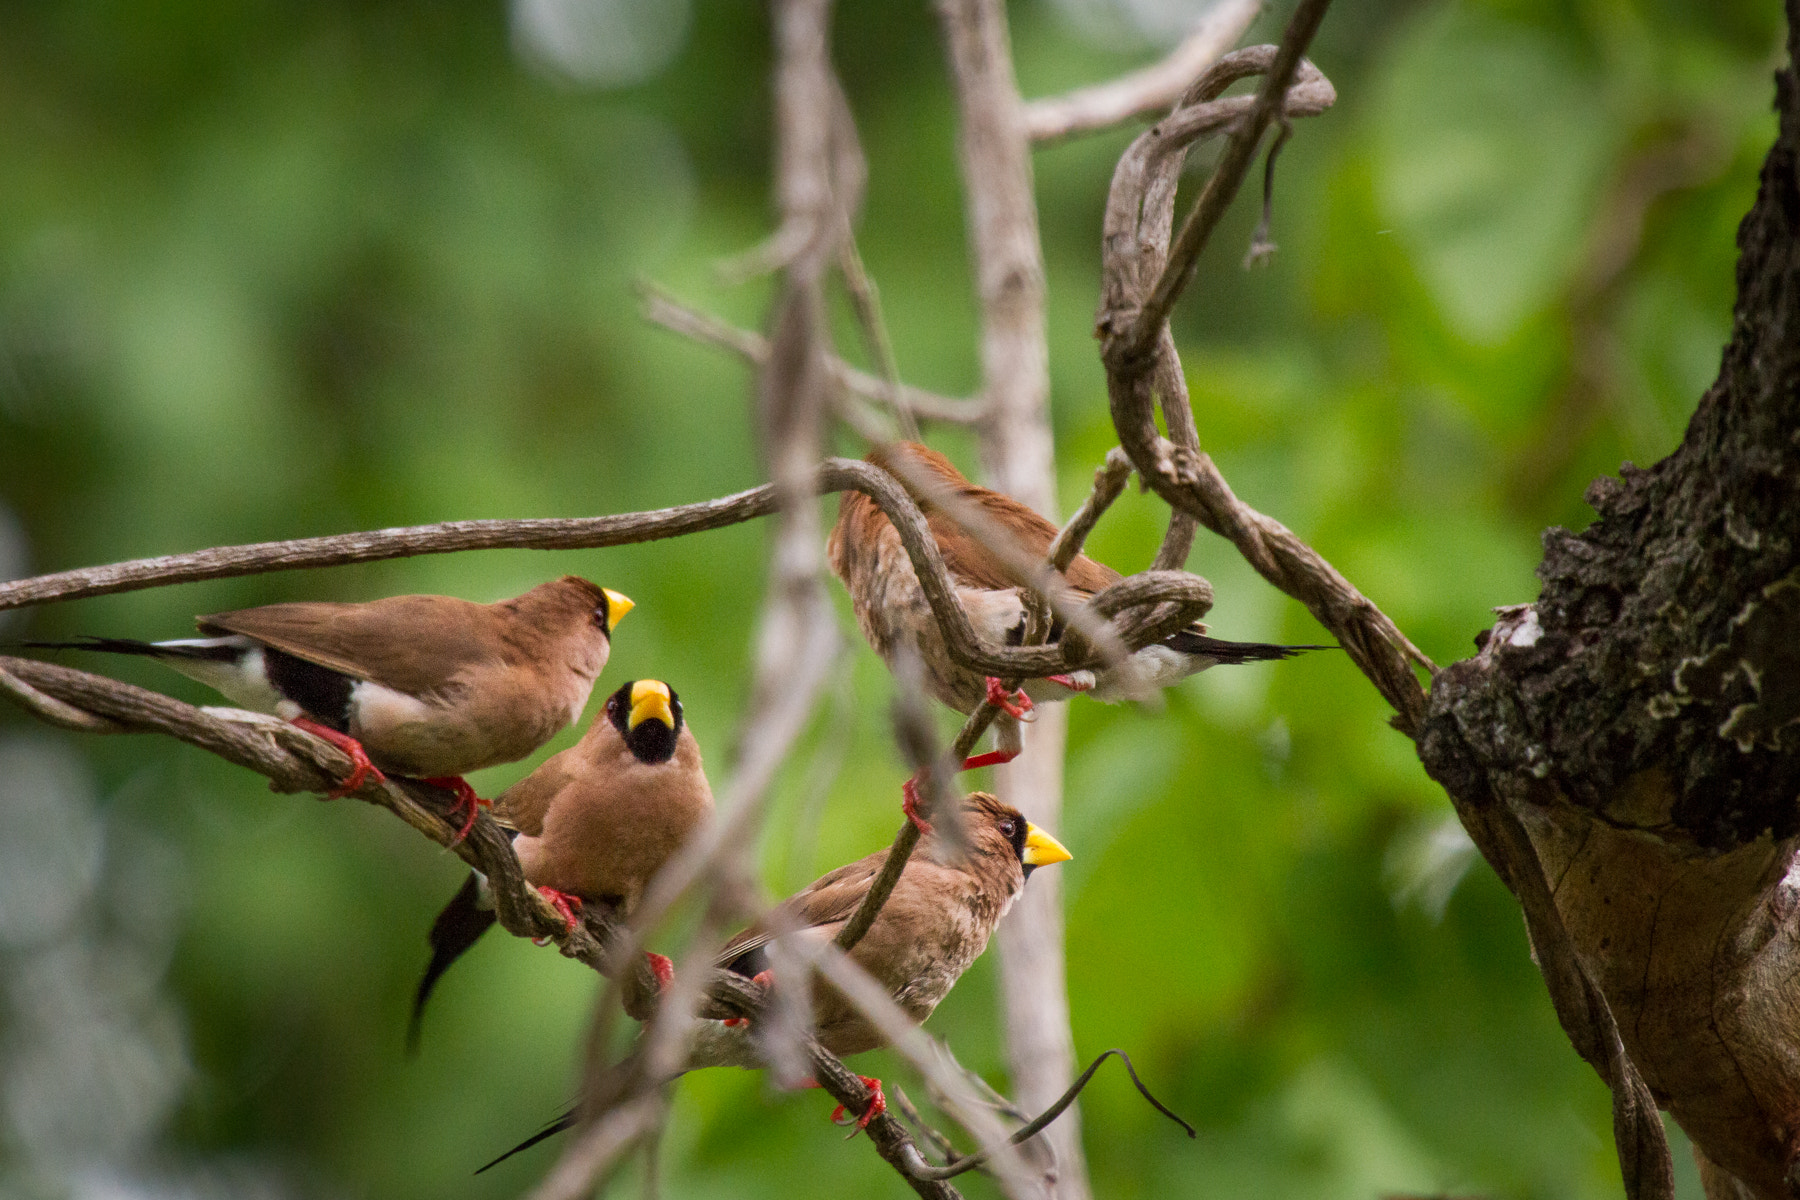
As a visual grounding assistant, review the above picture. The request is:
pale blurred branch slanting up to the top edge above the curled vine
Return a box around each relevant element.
[1024,0,1262,142]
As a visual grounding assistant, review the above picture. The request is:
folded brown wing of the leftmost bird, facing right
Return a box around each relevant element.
[198,596,504,696]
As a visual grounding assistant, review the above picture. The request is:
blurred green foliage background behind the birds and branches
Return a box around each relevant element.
[0,0,1782,1200]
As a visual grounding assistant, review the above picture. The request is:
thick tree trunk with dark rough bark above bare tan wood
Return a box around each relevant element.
[1418,14,1800,1198]
